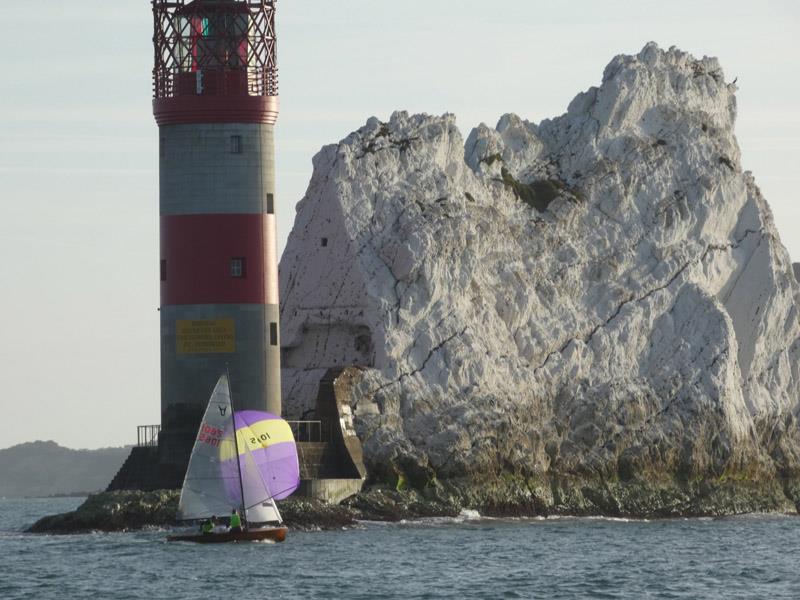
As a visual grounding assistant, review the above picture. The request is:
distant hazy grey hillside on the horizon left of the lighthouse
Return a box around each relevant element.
[0,441,130,497]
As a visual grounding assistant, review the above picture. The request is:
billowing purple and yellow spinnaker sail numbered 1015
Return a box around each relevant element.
[223,410,300,508]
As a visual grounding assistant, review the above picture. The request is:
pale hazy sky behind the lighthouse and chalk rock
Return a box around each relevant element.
[0,0,800,448]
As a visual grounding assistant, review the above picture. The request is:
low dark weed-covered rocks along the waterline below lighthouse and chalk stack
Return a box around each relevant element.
[27,476,800,534]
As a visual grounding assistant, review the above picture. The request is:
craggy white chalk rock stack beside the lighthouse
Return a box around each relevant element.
[280,44,800,512]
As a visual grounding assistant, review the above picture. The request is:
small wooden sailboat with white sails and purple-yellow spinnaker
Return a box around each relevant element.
[167,373,300,543]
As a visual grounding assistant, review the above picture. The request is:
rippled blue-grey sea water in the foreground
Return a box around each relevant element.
[0,498,800,600]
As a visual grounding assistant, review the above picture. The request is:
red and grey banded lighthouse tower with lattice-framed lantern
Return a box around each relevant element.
[152,0,281,463]
